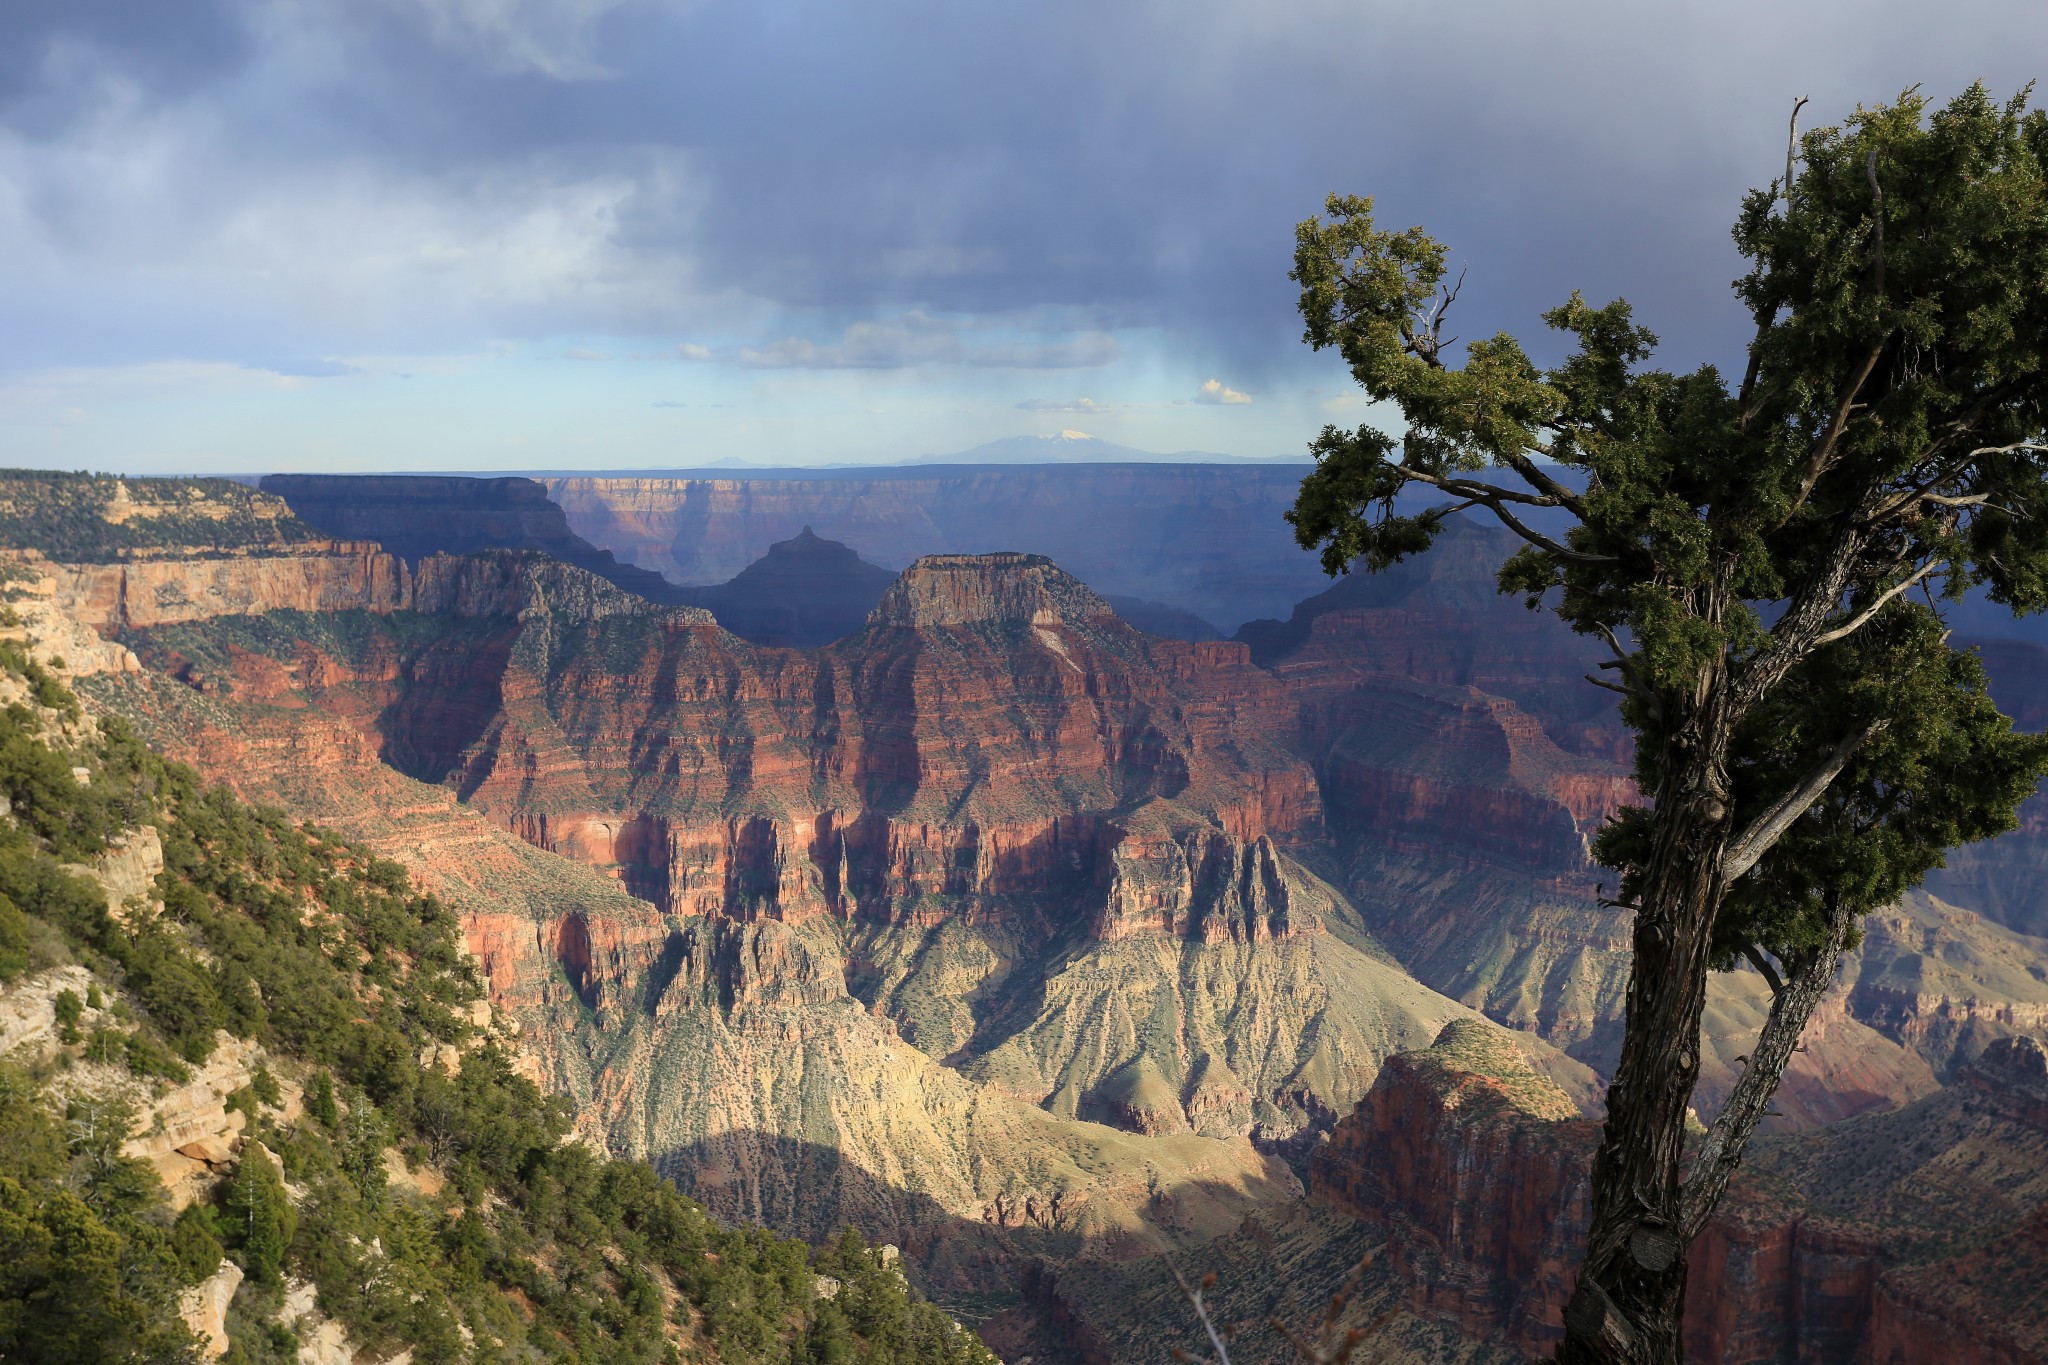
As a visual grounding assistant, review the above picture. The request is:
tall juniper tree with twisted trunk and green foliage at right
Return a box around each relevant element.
[1290,86,2048,1363]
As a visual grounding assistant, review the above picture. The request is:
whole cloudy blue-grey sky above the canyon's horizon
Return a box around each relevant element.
[0,0,2048,473]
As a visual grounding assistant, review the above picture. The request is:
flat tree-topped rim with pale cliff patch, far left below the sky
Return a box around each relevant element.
[0,469,326,563]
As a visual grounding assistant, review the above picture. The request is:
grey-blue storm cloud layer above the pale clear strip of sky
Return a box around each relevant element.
[0,0,2048,381]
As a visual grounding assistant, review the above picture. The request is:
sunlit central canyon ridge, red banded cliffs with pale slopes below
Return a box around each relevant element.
[79,540,1591,1309]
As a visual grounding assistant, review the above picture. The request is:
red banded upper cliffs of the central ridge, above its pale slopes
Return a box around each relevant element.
[360,557,1319,935]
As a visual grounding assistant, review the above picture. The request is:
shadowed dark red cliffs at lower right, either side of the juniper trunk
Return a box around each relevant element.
[1311,1023,2048,1365]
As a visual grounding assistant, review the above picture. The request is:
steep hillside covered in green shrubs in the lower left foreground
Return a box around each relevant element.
[0,661,993,1365]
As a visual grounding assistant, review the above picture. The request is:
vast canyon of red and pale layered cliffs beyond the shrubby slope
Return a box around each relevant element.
[16,467,2048,1361]
